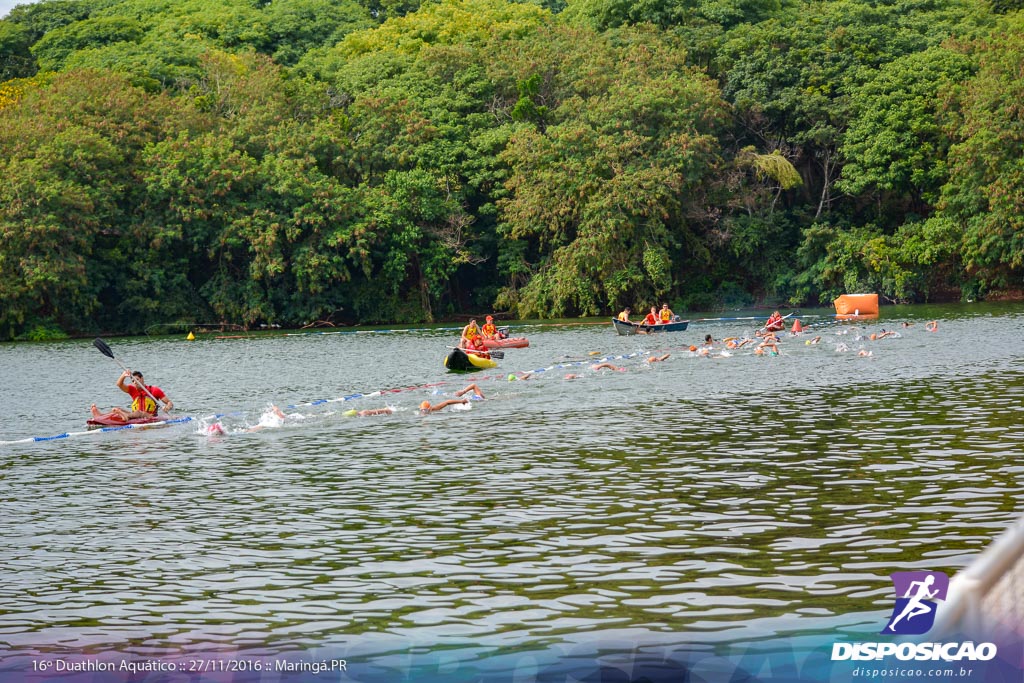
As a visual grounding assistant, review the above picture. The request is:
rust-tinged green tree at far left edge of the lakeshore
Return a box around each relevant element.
[0,72,180,336]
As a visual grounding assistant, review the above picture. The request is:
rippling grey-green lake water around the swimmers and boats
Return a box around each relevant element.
[0,304,1024,678]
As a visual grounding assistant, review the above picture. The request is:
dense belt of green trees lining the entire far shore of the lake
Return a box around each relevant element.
[0,0,1024,341]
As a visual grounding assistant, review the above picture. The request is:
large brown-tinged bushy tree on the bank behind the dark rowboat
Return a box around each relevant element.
[493,24,723,316]
